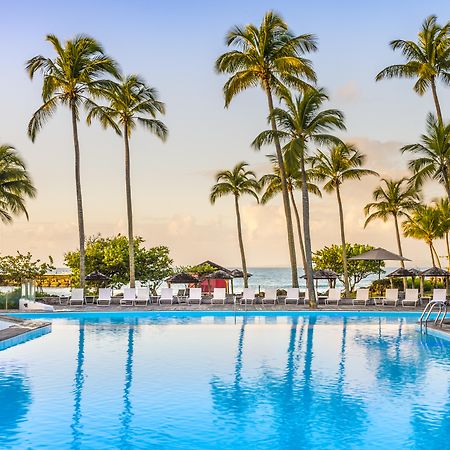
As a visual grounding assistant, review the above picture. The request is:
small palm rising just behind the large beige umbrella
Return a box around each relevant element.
[364,178,420,282]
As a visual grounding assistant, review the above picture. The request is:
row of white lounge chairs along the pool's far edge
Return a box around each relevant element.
[60,287,446,306]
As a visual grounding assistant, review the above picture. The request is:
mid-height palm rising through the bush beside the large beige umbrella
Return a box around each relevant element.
[313,143,378,295]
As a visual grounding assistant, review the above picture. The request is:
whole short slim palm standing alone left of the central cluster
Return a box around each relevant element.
[209,162,260,287]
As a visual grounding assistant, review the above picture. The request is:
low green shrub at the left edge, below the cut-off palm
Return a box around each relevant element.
[0,252,55,286]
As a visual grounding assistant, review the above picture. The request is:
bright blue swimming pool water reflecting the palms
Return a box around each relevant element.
[0,312,450,450]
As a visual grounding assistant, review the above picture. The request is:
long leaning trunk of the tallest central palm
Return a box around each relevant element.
[266,83,298,287]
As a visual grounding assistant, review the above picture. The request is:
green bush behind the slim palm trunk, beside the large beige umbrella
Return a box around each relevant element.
[313,244,384,290]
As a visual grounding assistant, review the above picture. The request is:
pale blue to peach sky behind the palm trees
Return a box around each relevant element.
[0,0,449,267]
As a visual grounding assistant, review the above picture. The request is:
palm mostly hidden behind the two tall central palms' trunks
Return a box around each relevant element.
[259,155,322,269]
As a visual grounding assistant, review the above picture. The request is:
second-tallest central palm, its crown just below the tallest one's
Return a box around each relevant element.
[252,88,345,307]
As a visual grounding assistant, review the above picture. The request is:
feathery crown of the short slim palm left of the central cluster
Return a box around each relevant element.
[209,162,260,204]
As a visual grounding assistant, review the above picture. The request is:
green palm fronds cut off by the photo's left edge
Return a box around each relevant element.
[0,144,36,223]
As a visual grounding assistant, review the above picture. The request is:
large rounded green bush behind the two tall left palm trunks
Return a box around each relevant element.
[64,234,173,290]
